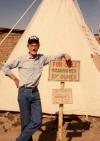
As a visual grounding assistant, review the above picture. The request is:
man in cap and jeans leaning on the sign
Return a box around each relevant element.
[2,36,71,141]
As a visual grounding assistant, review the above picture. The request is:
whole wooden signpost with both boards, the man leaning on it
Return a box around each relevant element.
[49,58,80,141]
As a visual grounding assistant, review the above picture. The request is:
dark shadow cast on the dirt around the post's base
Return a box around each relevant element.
[38,115,91,141]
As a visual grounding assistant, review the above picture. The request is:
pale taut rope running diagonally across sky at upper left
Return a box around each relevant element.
[0,0,37,46]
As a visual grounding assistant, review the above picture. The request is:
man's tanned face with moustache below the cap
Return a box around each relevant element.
[27,43,39,55]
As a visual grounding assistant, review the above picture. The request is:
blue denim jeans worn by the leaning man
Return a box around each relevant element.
[16,88,42,141]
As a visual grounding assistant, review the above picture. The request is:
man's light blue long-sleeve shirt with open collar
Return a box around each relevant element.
[2,53,61,87]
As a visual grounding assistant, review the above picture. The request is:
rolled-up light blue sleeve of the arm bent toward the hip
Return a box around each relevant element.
[1,57,20,75]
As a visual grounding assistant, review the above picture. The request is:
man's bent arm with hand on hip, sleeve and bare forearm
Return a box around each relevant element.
[1,57,20,88]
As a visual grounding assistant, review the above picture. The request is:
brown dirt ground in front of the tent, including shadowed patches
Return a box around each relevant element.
[0,112,100,141]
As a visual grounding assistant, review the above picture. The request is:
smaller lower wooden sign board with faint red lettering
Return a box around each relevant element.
[52,88,73,104]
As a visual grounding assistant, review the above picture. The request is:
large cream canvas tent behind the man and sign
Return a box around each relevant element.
[0,0,100,116]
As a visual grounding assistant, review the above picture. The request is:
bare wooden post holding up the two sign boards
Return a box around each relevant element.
[58,82,65,141]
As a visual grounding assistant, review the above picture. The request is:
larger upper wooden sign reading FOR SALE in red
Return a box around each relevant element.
[48,60,80,81]
